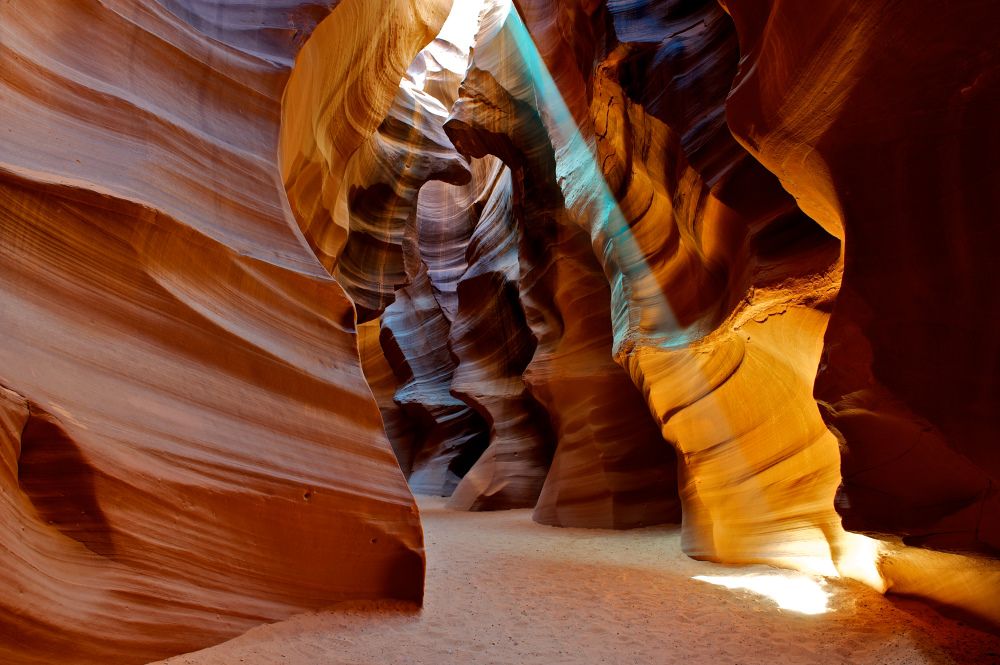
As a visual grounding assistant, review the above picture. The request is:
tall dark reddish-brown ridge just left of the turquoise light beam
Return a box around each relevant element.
[445,57,678,528]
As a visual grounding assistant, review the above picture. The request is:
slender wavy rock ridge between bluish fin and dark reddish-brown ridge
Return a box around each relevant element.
[448,157,553,510]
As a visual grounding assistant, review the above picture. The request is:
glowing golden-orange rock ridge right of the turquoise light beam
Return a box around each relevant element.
[591,2,841,571]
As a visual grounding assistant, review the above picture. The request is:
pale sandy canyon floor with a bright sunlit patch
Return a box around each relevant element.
[156,499,1000,665]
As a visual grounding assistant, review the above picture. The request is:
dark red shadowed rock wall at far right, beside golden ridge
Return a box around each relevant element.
[725,0,1000,556]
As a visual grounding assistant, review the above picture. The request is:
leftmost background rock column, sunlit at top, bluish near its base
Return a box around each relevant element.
[348,14,496,496]
